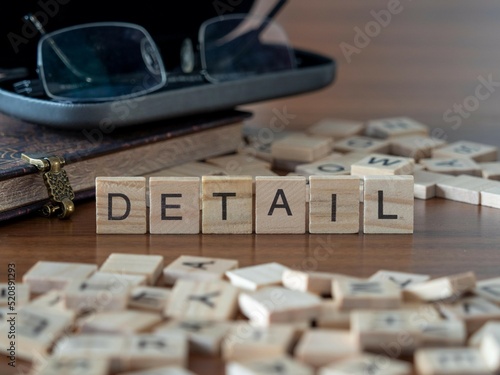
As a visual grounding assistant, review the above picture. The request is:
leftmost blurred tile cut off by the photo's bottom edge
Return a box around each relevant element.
[32,357,109,375]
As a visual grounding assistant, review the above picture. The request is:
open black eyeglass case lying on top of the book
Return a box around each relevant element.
[0,0,336,129]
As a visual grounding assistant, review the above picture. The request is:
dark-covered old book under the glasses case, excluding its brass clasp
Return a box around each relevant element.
[0,109,252,221]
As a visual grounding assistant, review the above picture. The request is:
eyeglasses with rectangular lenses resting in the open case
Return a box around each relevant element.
[14,0,296,102]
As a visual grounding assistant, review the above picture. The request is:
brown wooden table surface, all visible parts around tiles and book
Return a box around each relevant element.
[0,0,500,375]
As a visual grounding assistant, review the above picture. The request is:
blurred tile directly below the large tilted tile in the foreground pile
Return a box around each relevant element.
[222,321,296,361]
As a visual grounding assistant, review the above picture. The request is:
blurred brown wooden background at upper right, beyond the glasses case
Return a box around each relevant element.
[245,0,500,145]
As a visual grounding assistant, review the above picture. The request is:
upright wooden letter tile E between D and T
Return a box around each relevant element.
[149,177,201,234]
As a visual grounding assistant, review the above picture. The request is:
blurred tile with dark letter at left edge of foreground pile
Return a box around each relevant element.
[0,306,75,362]
